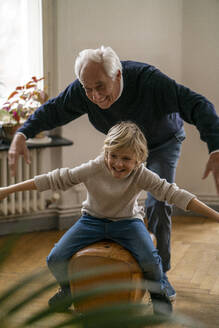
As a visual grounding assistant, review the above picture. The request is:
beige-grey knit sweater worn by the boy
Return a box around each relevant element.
[34,155,195,220]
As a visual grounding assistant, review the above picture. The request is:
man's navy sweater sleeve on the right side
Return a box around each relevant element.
[152,70,219,152]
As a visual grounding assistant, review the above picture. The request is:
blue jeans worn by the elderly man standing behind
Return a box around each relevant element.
[145,128,185,272]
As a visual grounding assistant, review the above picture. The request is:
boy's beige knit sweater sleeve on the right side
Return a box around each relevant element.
[140,168,196,211]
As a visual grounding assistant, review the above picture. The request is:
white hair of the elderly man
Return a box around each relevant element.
[75,46,122,81]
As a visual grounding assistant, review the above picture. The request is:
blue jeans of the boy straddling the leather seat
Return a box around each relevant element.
[47,215,164,293]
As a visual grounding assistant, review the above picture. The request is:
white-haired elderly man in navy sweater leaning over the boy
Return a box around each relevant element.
[9,46,219,300]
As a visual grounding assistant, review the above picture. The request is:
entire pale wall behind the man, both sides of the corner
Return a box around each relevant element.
[48,0,219,208]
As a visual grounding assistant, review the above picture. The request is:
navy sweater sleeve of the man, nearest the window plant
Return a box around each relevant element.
[18,80,87,138]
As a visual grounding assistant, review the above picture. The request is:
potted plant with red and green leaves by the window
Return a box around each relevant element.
[0,76,48,140]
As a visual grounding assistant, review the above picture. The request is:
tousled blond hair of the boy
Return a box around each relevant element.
[103,121,148,164]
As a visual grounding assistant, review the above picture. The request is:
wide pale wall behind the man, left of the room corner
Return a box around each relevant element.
[57,0,182,165]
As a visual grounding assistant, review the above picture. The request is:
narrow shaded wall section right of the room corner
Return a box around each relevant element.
[177,0,219,196]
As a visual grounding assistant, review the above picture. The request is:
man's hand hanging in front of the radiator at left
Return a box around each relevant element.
[8,133,30,176]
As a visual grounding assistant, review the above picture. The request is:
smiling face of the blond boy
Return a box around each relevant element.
[105,148,138,179]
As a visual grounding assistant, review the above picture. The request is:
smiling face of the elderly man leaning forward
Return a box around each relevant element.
[80,61,121,109]
